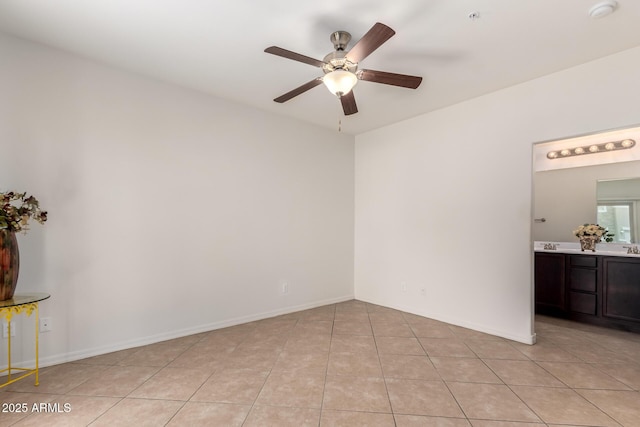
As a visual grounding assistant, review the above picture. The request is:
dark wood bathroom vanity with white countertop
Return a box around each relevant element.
[534,242,640,333]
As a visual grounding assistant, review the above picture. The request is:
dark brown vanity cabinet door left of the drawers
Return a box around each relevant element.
[534,252,565,314]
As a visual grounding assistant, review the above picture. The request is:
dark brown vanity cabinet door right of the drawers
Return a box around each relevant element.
[602,257,640,322]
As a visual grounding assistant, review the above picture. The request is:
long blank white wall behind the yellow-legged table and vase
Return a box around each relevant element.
[0,36,354,365]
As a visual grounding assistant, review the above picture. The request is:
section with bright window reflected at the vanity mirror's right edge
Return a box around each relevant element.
[596,178,640,243]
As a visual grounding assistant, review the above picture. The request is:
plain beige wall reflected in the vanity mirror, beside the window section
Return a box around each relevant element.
[533,161,640,242]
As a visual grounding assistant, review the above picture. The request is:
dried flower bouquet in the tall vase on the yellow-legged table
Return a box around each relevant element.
[0,191,47,233]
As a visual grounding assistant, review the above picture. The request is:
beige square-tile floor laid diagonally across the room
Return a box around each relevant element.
[0,301,640,427]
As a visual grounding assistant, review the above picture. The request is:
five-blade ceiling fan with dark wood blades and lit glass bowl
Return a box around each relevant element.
[264,22,422,116]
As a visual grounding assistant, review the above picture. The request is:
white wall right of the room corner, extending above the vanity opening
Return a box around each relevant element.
[355,48,640,342]
